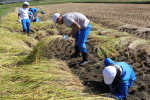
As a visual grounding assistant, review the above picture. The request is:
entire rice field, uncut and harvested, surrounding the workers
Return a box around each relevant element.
[0,3,150,100]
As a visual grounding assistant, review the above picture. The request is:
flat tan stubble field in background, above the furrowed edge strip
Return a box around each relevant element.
[33,3,150,27]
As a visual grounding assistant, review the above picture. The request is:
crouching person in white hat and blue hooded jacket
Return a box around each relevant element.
[103,58,136,100]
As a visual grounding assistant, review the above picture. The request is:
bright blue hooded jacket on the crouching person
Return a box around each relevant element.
[104,58,136,99]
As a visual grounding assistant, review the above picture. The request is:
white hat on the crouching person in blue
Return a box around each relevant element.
[103,66,117,84]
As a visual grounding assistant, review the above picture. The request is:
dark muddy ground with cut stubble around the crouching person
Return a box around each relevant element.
[48,37,150,100]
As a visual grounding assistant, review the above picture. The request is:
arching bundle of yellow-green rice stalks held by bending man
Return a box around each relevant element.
[25,35,73,62]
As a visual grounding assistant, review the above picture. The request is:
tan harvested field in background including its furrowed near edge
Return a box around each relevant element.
[29,3,150,39]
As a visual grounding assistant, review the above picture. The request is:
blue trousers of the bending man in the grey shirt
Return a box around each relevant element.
[74,24,92,53]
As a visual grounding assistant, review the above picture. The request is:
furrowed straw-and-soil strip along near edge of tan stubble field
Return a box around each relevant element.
[96,20,150,40]
